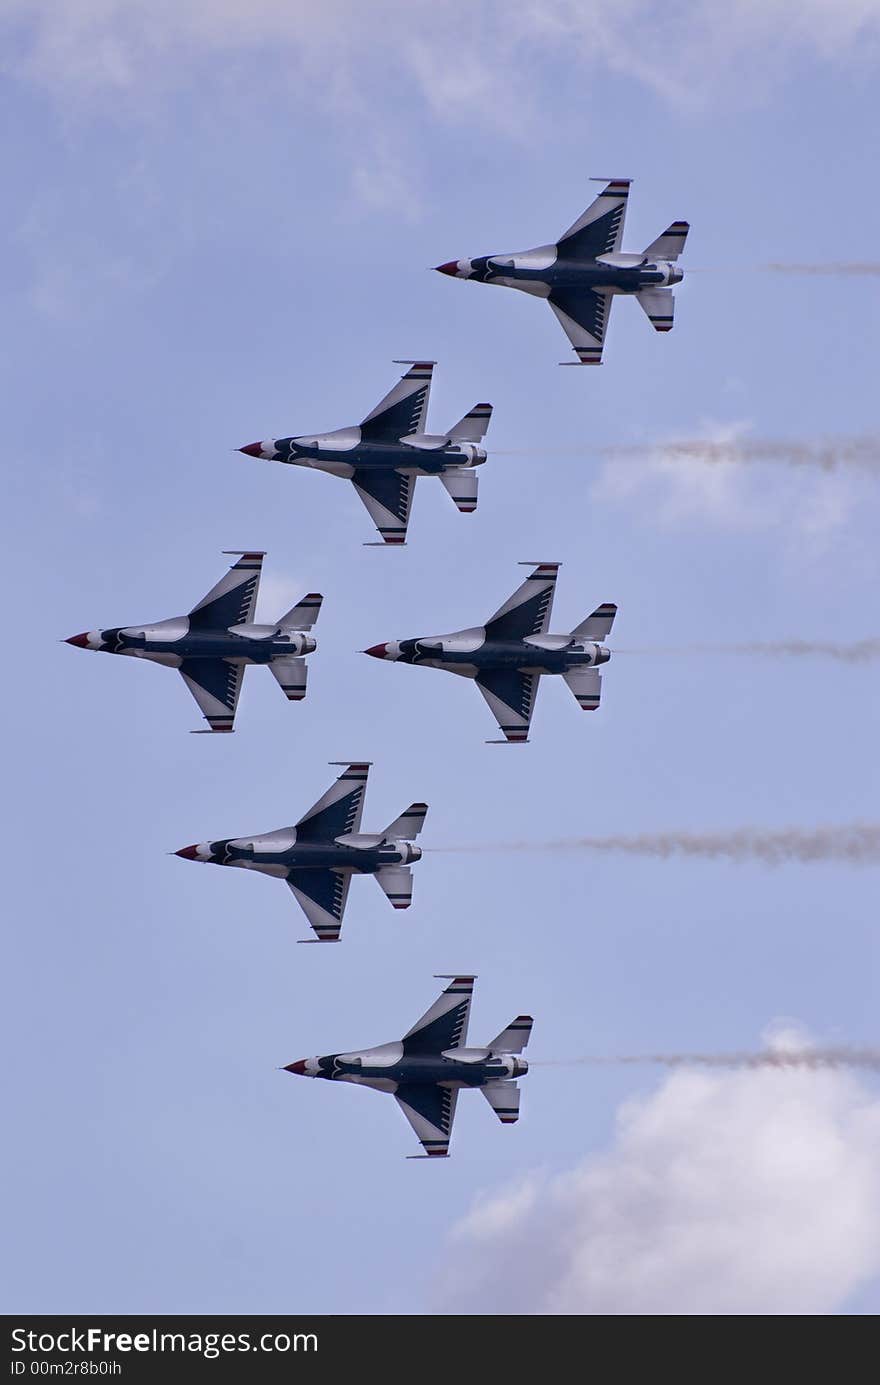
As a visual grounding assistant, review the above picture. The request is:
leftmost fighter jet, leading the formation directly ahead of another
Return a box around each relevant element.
[67,550,323,734]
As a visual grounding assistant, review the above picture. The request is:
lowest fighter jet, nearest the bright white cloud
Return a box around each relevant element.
[284,976,532,1159]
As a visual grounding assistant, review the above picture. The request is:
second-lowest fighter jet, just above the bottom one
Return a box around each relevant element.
[175,760,428,943]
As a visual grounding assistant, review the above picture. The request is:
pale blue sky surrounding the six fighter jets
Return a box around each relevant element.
[0,0,880,1313]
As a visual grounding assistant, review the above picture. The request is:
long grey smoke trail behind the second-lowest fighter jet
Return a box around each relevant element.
[430,823,880,866]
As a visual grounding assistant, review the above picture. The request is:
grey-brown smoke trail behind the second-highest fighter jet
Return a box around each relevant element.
[599,434,880,471]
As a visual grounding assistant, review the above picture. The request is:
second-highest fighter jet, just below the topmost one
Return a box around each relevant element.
[238,360,492,547]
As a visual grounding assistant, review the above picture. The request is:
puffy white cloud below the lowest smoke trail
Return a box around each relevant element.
[434,1035,880,1316]
